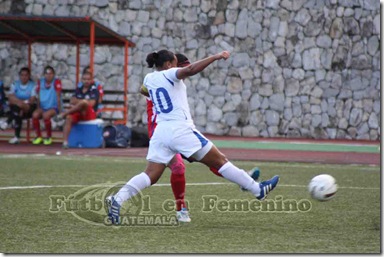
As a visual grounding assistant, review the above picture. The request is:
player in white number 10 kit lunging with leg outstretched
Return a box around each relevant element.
[106,50,279,224]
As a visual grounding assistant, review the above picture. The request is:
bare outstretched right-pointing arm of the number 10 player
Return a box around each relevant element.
[176,51,230,79]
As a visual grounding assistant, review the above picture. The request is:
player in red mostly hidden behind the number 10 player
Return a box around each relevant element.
[140,53,259,222]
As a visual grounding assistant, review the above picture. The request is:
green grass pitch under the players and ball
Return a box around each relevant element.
[0,156,381,253]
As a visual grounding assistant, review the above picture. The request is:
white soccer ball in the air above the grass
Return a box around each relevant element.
[308,174,337,201]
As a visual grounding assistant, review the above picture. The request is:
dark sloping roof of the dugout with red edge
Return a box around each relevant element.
[0,15,135,47]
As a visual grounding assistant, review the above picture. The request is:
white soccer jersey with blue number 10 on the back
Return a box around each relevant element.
[143,68,193,123]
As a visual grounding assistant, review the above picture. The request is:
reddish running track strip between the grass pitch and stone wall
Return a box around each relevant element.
[0,141,381,165]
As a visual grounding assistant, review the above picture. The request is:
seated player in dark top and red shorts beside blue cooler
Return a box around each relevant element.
[57,72,99,148]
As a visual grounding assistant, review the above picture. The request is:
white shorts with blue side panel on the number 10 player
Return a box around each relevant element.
[147,121,213,164]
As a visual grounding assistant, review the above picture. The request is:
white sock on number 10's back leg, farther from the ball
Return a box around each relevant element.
[115,172,151,206]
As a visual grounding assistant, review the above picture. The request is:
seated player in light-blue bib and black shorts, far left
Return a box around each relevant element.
[1,67,36,144]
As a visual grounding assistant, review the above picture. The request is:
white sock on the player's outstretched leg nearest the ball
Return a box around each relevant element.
[219,162,260,196]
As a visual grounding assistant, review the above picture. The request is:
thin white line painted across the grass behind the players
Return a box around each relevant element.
[0,182,380,190]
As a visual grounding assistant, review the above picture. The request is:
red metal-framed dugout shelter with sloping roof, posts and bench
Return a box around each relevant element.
[0,14,135,132]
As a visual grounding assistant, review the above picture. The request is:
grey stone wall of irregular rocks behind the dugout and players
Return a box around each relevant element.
[0,0,381,140]
